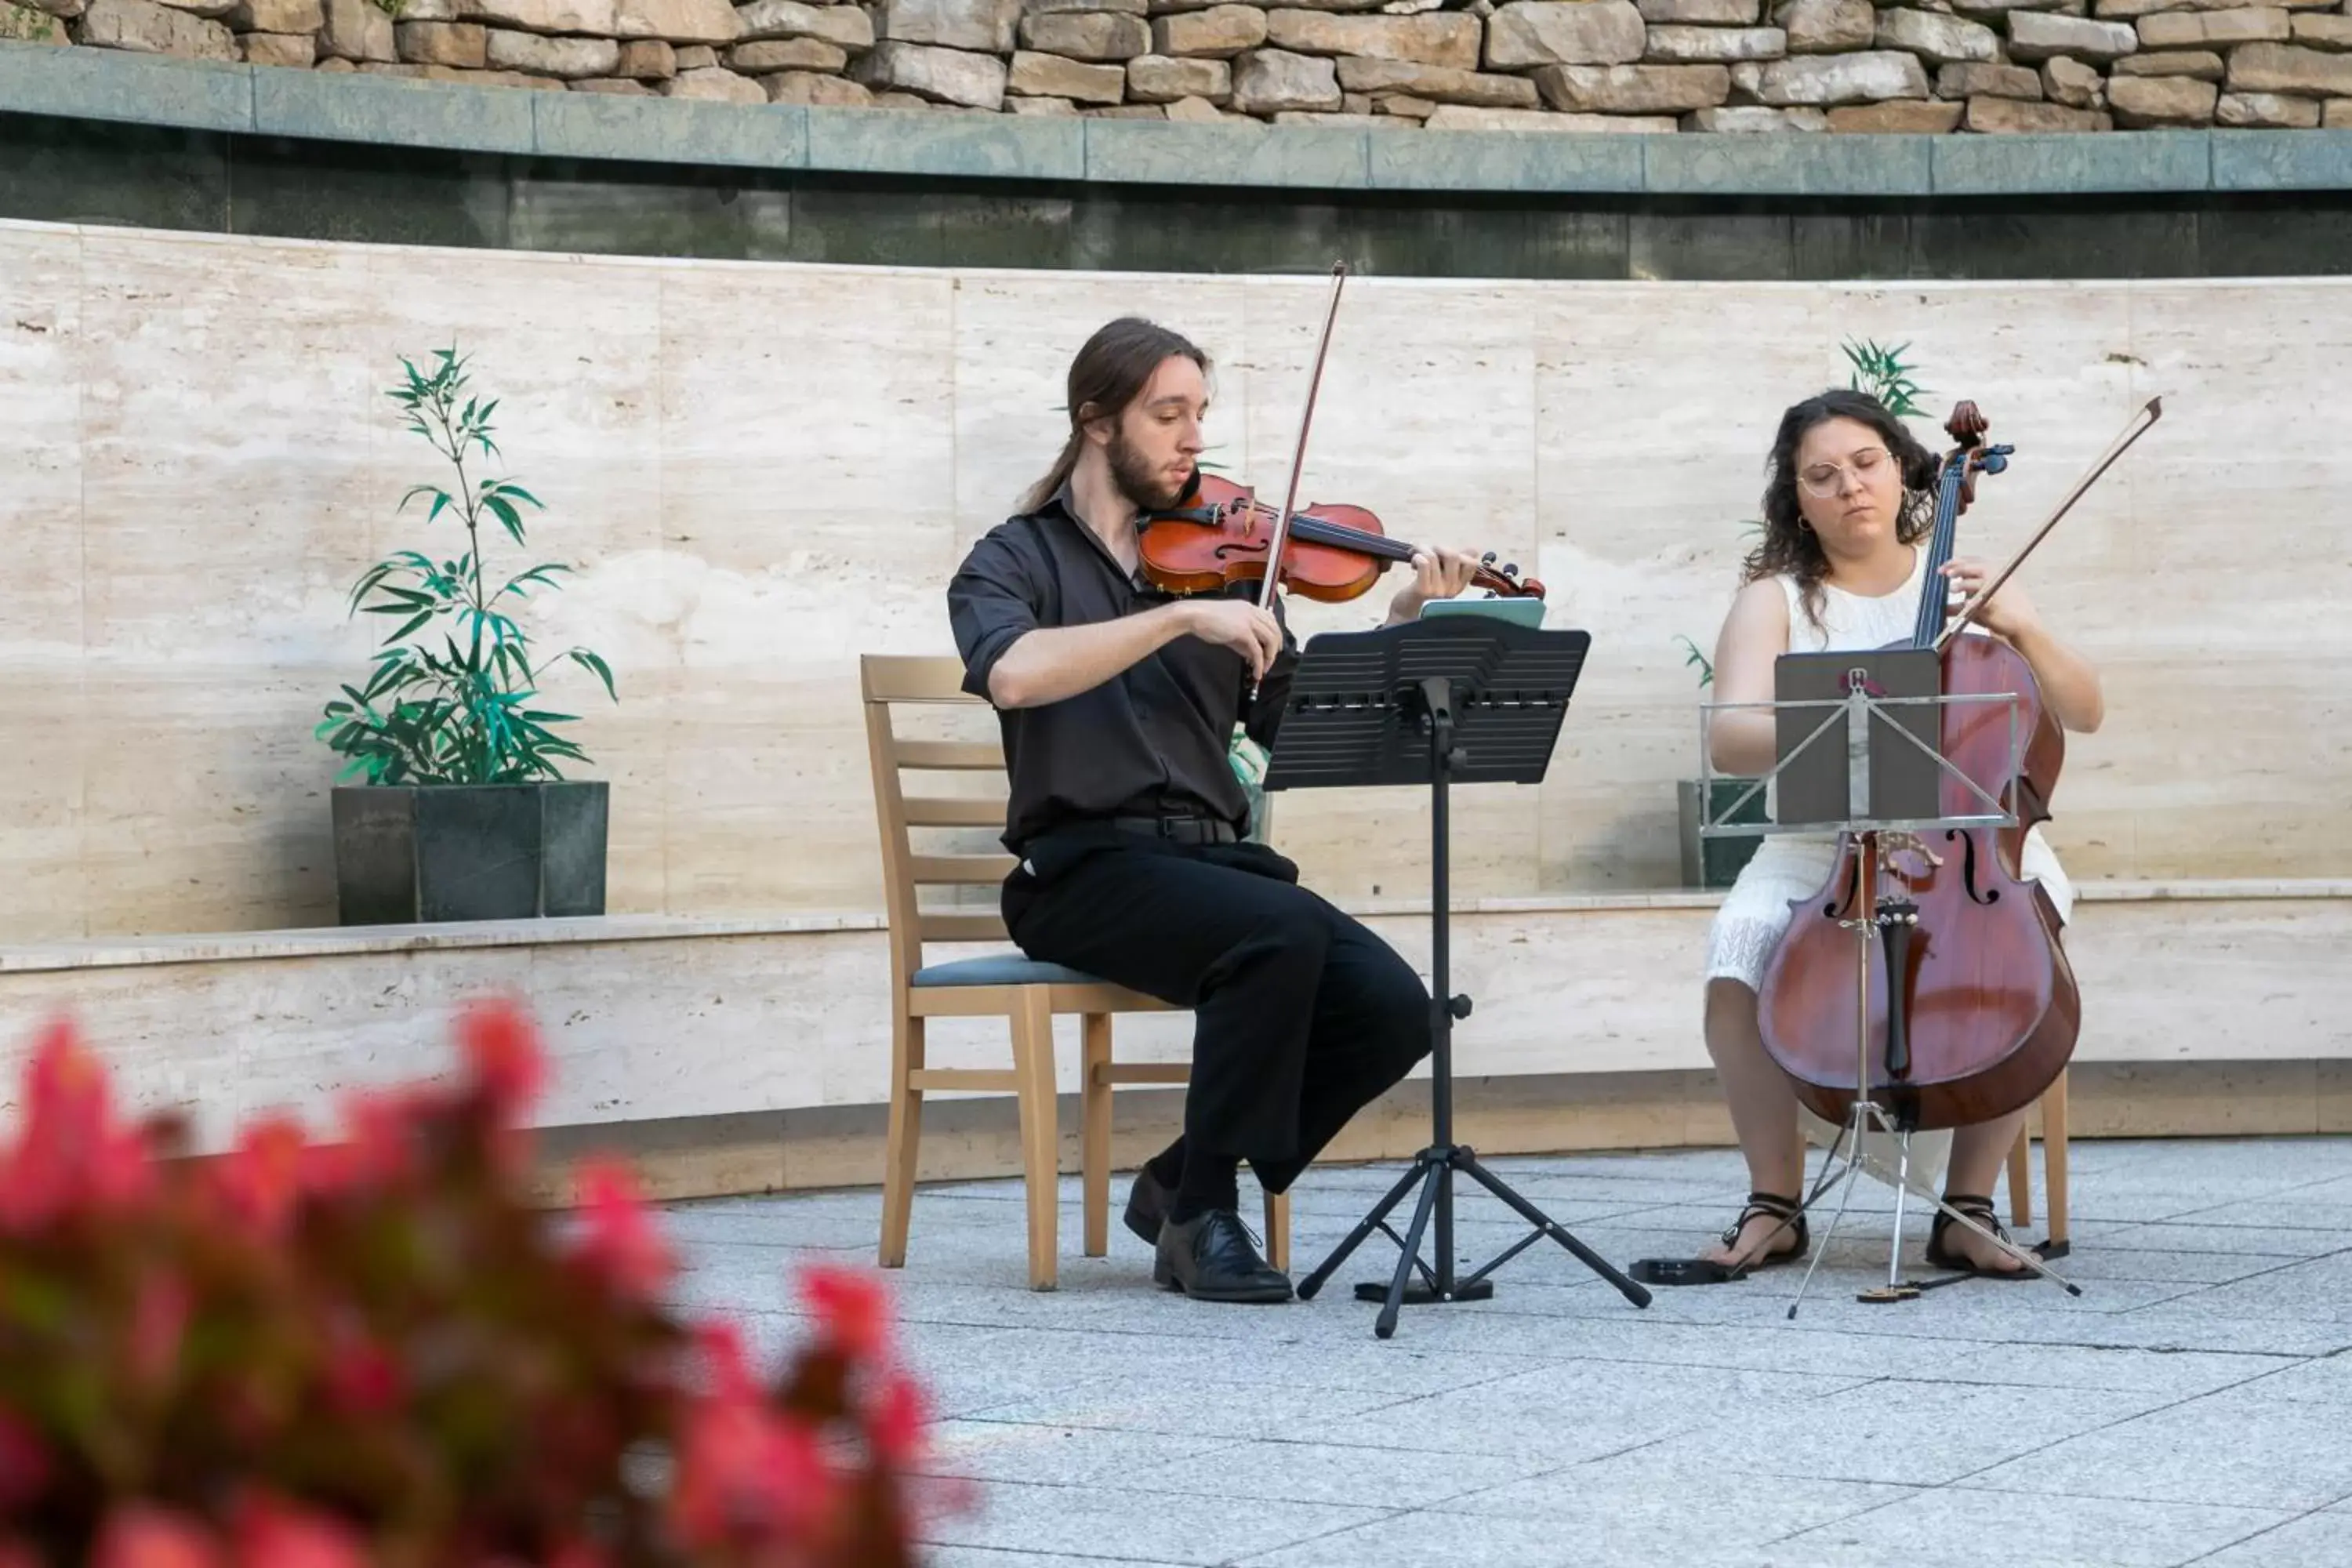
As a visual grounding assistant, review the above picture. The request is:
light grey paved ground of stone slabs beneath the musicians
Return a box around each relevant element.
[670,1138,2352,1568]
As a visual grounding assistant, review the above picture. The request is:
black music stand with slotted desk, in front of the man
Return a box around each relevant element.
[1265,614,1649,1340]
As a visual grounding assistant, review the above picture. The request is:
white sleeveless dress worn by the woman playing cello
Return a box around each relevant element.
[1708,546,2074,1189]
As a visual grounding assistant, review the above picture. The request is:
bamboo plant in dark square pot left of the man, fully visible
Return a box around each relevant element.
[315,348,619,926]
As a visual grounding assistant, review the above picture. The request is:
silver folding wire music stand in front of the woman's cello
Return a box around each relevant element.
[1698,647,2082,1319]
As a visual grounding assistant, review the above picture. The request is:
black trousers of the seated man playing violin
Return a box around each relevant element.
[1004,825,1430,1192]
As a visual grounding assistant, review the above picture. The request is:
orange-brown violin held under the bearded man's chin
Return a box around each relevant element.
[1136,475,1543,604]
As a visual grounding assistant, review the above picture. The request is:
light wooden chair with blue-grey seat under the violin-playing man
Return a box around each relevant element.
[858,654,1289,1290]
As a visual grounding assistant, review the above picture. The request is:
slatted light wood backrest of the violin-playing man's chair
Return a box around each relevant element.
[858,654,1014,987]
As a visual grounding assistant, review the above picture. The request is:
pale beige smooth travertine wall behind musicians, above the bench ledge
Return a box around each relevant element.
[0,223,2352,940]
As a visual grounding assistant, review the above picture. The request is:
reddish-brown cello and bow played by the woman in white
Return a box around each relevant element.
[1757,397,2161,1131]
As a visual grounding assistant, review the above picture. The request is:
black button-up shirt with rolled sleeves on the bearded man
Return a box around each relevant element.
[948,485,1298,853]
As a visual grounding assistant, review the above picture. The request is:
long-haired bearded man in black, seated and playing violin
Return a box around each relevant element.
[948,318,1477,1302]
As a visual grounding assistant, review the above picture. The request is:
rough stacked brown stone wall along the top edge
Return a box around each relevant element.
[13,0,2352,134]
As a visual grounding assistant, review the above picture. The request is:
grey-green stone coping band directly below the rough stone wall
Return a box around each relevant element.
[13,45,2352,198]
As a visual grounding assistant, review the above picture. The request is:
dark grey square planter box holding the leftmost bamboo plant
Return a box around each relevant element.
[334,781,609,926]
